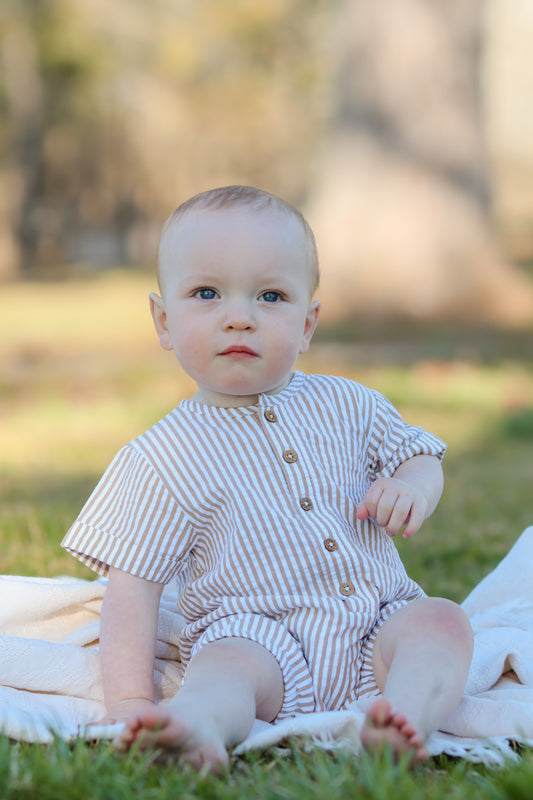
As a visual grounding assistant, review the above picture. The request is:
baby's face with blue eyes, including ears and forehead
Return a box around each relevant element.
[151,207,319,407]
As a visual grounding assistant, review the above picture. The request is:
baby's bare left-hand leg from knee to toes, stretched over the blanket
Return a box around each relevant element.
[118,638,283,770]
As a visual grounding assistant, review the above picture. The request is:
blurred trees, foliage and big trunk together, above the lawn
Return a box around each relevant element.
[0,0,533,327]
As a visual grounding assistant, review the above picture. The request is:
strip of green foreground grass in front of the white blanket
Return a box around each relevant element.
[0,738,533,800]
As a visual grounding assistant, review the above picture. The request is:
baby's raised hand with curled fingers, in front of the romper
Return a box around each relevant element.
[357,478,428,539]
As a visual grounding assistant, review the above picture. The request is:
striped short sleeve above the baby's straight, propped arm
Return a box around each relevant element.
[61,445,188,583]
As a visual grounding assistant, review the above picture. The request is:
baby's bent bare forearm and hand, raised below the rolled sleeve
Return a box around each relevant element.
[357,455,443,539]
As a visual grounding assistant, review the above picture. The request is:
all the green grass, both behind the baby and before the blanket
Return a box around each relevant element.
[0,271,533,800]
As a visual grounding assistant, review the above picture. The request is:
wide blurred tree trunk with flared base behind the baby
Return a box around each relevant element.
[308,0,533,323]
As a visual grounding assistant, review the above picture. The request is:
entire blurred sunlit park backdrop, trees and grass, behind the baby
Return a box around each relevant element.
[0,0,533,594]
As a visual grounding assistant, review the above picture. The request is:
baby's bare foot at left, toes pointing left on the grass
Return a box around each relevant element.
[116,703,229,773]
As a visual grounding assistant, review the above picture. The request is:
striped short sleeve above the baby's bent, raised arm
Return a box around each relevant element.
[368,392,446,480]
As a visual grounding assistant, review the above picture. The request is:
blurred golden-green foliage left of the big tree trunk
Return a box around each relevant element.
[0,0,327,274]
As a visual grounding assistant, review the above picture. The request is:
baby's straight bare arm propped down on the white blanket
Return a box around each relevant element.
[100,568,163,723]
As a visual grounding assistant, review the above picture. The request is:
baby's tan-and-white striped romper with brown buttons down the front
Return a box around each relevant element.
[62,372,445,719]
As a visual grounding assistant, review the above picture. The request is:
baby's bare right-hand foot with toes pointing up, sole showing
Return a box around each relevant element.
[361,698,429,763]
